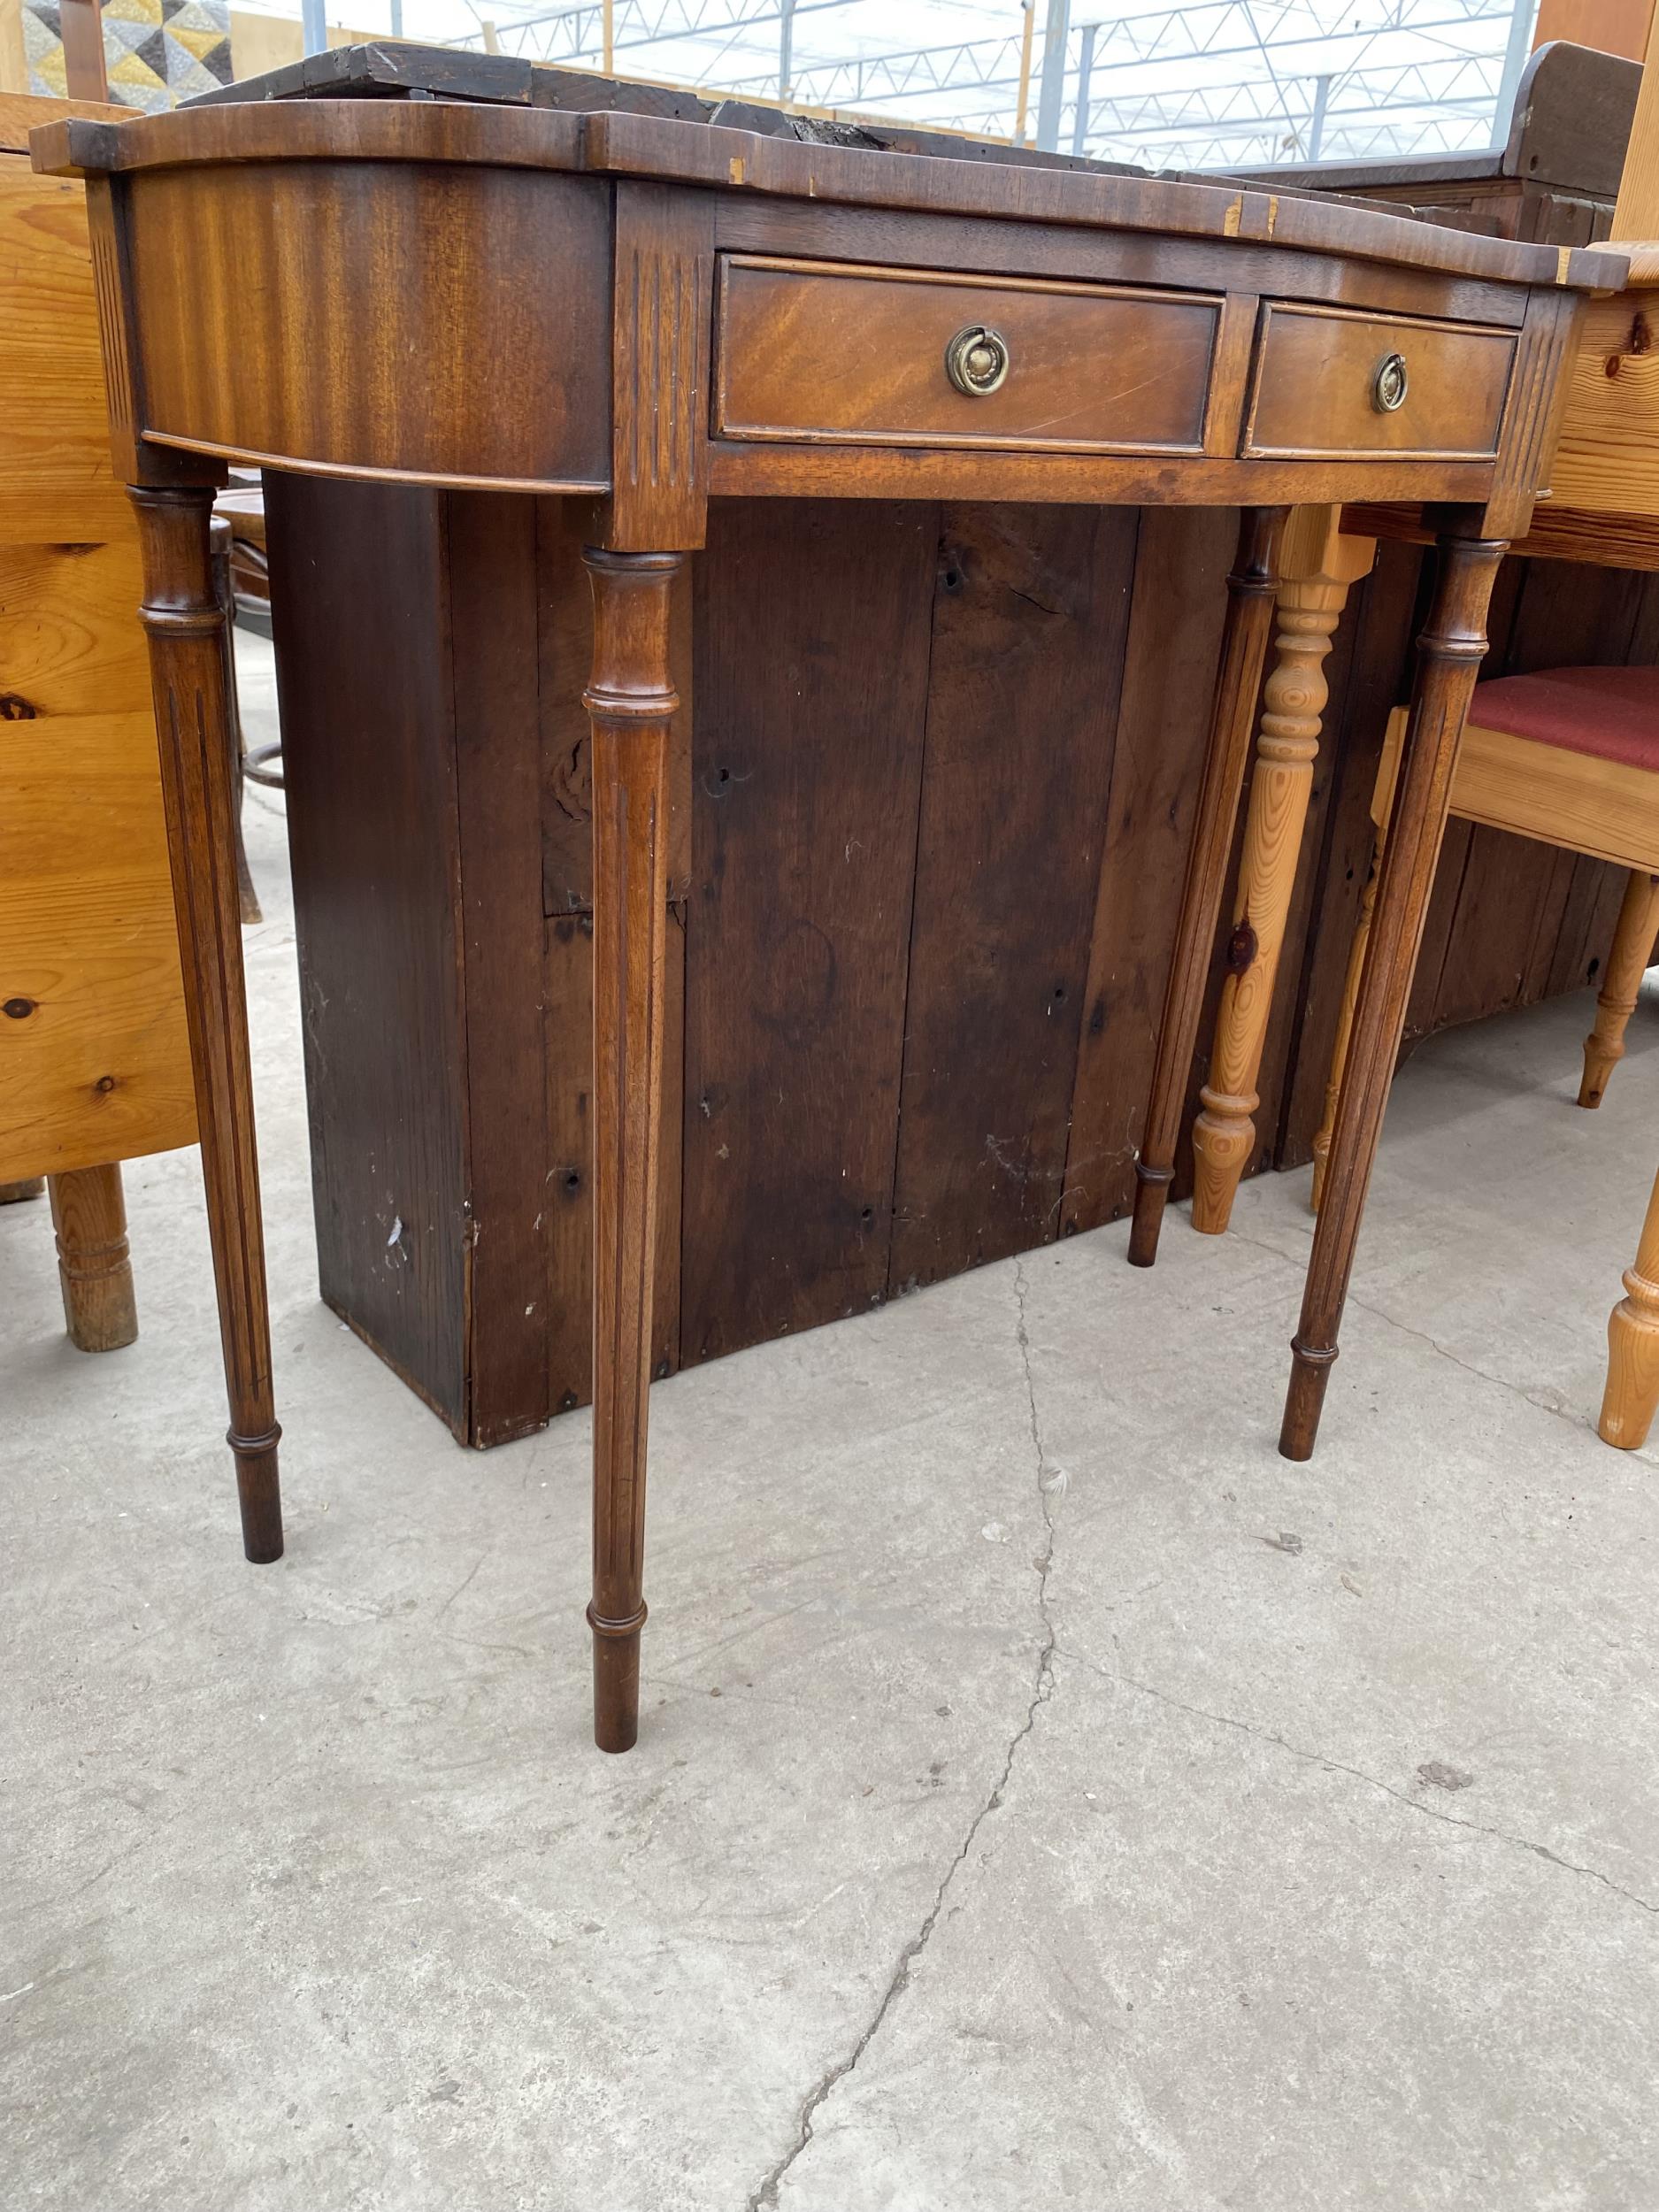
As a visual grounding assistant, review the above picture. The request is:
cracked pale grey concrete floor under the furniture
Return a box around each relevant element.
[0,646,1659,2212]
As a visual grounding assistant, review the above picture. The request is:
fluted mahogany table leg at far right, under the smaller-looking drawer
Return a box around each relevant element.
[1279,515,1507,1460]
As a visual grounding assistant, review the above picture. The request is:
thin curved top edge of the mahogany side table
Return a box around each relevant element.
[31,100,1624,292]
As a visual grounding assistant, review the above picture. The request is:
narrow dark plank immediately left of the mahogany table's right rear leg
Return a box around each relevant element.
[1060,507,1239,1234]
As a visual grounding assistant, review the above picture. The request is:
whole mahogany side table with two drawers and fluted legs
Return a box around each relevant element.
[34,86,1622,1752]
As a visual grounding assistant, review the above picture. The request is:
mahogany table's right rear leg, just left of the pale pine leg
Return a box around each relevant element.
[1128,507,1287,1268]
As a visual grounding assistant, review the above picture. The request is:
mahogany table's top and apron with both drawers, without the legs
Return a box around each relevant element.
[34,80,1622,549]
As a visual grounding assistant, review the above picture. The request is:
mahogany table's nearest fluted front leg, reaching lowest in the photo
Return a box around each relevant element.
[582,547,684,1752]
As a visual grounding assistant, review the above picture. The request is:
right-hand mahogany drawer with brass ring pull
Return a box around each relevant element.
[1241,301,1516,460]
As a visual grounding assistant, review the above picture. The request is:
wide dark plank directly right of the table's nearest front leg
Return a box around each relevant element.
[681,500,938,1361]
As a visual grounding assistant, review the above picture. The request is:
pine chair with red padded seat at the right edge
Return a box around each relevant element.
[1314,668,1659,1451]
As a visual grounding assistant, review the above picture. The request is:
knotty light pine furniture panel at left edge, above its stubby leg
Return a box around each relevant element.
[0,129,197,1179]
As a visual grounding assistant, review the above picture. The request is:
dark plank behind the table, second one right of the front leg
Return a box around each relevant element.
[889,507,1140,1292]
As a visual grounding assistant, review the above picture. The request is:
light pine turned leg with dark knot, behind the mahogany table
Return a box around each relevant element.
[1193,507,1376,1237]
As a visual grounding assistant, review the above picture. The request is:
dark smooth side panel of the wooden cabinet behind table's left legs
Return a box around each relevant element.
[265,476,467,1436]
